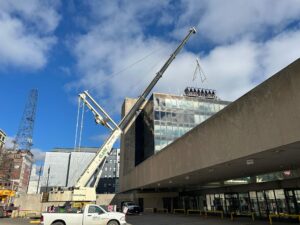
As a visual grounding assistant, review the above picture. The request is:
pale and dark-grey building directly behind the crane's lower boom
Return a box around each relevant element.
[40,148,119,193]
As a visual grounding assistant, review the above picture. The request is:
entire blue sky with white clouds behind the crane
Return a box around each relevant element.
[0,0,300,163]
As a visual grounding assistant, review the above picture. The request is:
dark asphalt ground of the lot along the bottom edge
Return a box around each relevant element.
[0,214,299,225]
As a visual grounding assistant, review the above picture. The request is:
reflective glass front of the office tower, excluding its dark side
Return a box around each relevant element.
[153,94,229,152]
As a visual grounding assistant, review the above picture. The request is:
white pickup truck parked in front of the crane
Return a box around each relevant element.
[41,204,127,225]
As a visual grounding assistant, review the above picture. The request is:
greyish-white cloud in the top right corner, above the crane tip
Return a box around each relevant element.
[178,0,300,43]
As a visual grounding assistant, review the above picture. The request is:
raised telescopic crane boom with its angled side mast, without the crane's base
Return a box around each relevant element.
[56,27,196,201]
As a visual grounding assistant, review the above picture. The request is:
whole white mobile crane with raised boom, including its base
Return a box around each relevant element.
[49,27,196,202]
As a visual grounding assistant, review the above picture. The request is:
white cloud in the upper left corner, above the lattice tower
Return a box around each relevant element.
[0,0,60,69]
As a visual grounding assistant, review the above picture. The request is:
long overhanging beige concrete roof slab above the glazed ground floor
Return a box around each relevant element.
[120,59,300,191]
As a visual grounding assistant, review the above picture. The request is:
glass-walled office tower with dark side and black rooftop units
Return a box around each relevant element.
[135,88,230,164]
